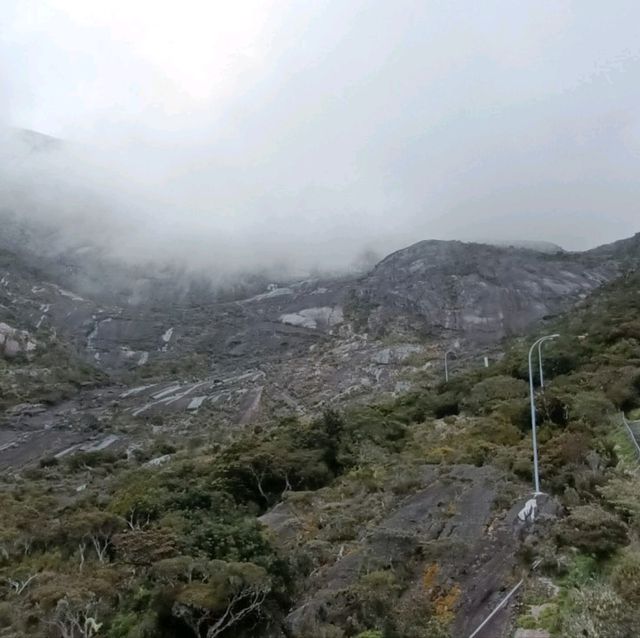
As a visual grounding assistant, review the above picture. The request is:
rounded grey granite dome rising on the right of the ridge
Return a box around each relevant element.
[353,241,619,343]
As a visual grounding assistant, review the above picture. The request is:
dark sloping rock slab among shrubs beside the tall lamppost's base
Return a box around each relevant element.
[268,465,544,638]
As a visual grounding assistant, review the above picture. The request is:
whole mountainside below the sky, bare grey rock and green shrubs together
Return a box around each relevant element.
[0,230,640,638]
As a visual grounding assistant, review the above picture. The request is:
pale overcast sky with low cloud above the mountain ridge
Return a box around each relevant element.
[0,0,640,269]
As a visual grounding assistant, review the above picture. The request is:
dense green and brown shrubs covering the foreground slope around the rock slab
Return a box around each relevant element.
[0,274,640,638]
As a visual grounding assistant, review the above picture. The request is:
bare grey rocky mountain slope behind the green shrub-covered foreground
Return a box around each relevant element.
[0,218,639,464]
